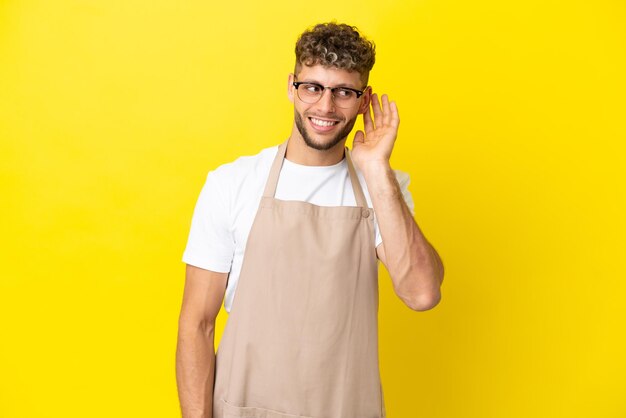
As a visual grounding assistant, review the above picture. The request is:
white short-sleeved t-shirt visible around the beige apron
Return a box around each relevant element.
[183,146,413,312]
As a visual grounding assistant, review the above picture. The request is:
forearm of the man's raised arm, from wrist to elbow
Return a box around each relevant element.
[363,163,443,310]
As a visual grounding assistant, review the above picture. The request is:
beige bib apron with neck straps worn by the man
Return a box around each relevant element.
[213,142,385,418]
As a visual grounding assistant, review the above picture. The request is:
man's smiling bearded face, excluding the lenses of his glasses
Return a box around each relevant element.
[289,65,370,151]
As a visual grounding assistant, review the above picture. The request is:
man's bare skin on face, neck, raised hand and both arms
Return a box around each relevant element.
[176,65,444,418]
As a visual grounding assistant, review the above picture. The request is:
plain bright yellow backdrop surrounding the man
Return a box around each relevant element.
[0,0,626,418]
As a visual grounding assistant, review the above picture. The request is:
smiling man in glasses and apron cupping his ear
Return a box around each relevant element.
[177,23,443,418]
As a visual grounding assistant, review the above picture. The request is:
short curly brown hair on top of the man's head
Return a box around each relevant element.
[294,22,376,84]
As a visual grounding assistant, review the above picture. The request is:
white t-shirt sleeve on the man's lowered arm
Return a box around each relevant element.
[183,172,235,273]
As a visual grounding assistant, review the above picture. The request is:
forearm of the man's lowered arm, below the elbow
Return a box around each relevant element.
[176,327,215,418]
